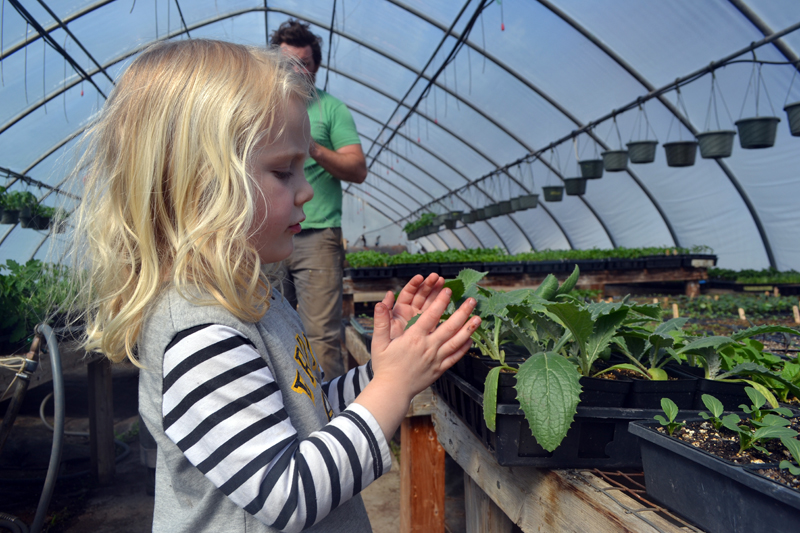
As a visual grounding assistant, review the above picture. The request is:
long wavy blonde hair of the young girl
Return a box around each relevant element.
[72,40,314,364]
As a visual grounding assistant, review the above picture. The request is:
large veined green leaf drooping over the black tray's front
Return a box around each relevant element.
[515,352,581,452]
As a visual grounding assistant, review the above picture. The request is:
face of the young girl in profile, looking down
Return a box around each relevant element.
[250,100,314,263]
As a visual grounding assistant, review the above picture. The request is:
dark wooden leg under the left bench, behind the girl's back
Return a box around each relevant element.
[87,357,115,485]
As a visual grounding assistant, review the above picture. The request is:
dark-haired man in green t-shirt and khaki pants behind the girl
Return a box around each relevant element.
[270,19,367,380]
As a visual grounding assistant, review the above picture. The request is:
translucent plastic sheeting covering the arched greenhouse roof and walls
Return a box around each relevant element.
[0,0,800,270]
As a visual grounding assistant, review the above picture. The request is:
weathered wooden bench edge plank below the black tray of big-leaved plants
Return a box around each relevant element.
[432,395,685,533]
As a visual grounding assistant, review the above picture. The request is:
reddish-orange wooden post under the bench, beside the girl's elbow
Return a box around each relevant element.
[400,415,444,533]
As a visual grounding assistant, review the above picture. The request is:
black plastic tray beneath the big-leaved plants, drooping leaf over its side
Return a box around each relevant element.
[435,371,683,469]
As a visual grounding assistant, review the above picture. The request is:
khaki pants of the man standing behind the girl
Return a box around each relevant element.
[282,228,344,381]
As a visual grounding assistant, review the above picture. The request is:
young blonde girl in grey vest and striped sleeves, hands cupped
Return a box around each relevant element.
[69,40,479,533]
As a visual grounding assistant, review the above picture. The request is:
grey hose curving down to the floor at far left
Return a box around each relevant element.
[31,324,64,533]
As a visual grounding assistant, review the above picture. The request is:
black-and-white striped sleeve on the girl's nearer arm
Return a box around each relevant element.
[162,325,391,531]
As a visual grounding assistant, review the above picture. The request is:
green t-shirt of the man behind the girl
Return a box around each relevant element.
[302,89,361,229]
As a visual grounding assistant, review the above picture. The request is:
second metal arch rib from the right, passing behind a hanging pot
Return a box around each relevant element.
[537,0,777,268]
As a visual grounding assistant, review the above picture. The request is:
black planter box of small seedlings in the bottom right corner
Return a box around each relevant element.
[630,422,800,533]
